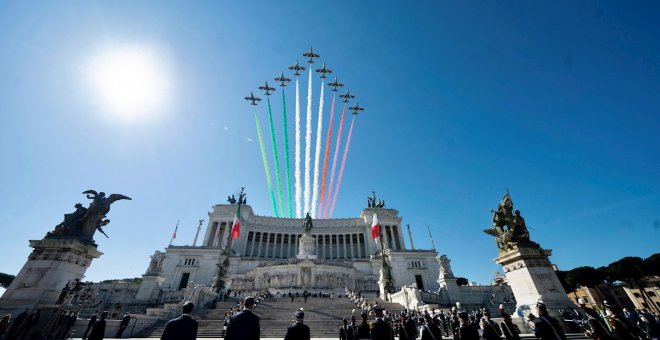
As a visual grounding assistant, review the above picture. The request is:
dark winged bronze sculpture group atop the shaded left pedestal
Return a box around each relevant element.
[46,190,131,245]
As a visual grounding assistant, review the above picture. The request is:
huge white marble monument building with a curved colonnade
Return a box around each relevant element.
[136,204,440,301]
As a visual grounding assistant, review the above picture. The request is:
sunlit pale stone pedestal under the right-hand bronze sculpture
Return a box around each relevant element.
[495,244,575,320]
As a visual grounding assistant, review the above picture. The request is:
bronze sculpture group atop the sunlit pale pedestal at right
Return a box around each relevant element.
[484,191,538,250]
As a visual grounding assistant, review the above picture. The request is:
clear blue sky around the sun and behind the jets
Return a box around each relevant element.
[0,1,660,283]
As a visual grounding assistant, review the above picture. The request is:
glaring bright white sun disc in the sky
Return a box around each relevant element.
[87,46,171,122]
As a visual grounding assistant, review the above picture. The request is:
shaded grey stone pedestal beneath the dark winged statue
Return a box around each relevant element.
[0,239,103,314]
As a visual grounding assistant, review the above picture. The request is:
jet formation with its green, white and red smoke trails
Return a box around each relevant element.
[245,47,364,218]
